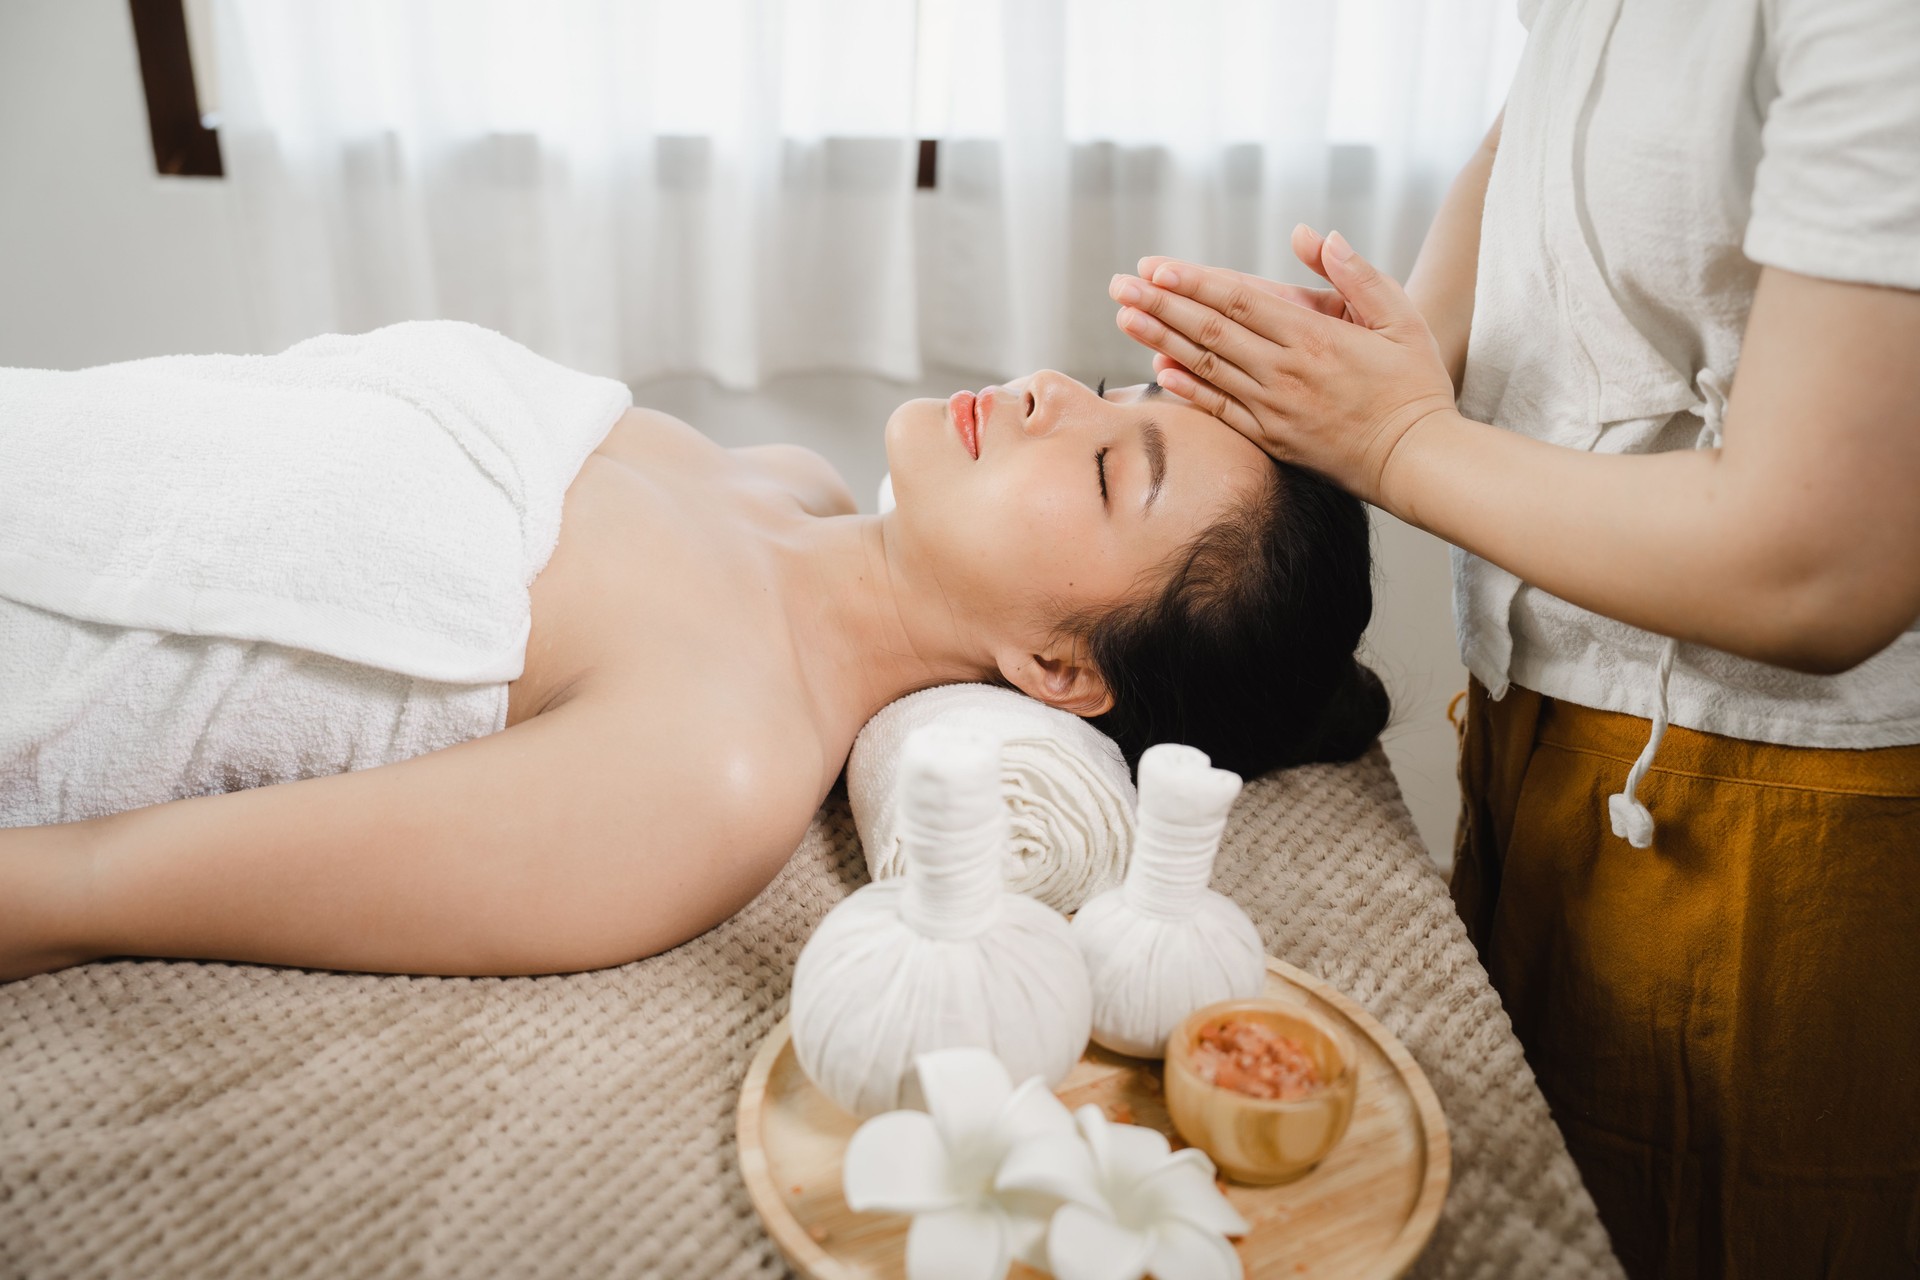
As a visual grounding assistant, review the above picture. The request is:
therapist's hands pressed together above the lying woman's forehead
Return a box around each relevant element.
[1108,230,1453,507]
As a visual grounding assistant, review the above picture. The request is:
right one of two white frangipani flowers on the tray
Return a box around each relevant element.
[995,1105,1252,1280]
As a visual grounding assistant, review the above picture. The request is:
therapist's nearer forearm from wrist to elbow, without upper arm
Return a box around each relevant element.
[1382,413,1905,674]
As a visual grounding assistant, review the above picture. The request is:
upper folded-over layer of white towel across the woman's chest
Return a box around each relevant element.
[0,320,632,683]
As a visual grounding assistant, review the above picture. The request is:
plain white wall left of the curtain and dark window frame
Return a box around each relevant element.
[0,0,252,368]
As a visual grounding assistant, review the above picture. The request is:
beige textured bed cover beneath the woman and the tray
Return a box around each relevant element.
[0,748,1620,1280]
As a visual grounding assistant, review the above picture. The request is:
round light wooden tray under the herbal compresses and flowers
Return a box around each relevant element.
[737,956,1452,1280]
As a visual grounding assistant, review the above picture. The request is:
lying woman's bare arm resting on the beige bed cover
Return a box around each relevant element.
[18,697,812,975]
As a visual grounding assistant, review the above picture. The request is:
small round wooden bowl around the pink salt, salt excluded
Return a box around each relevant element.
[1165,1000,1359,1186]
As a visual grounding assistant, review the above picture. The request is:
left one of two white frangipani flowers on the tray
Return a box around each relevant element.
[841,1048,1081,1280]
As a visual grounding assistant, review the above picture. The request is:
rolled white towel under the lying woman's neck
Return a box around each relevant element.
[847,685,1135,912]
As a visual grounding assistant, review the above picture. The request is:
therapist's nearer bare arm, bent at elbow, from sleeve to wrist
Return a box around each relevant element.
[1380,267,1920,674]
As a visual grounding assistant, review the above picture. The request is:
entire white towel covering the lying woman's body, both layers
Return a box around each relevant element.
[0,320,632,825]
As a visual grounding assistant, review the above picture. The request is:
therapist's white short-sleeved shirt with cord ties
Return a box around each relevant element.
[1453,0,1920,747]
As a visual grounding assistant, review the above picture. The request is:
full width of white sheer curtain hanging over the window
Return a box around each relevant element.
[213,0,1517,386]
